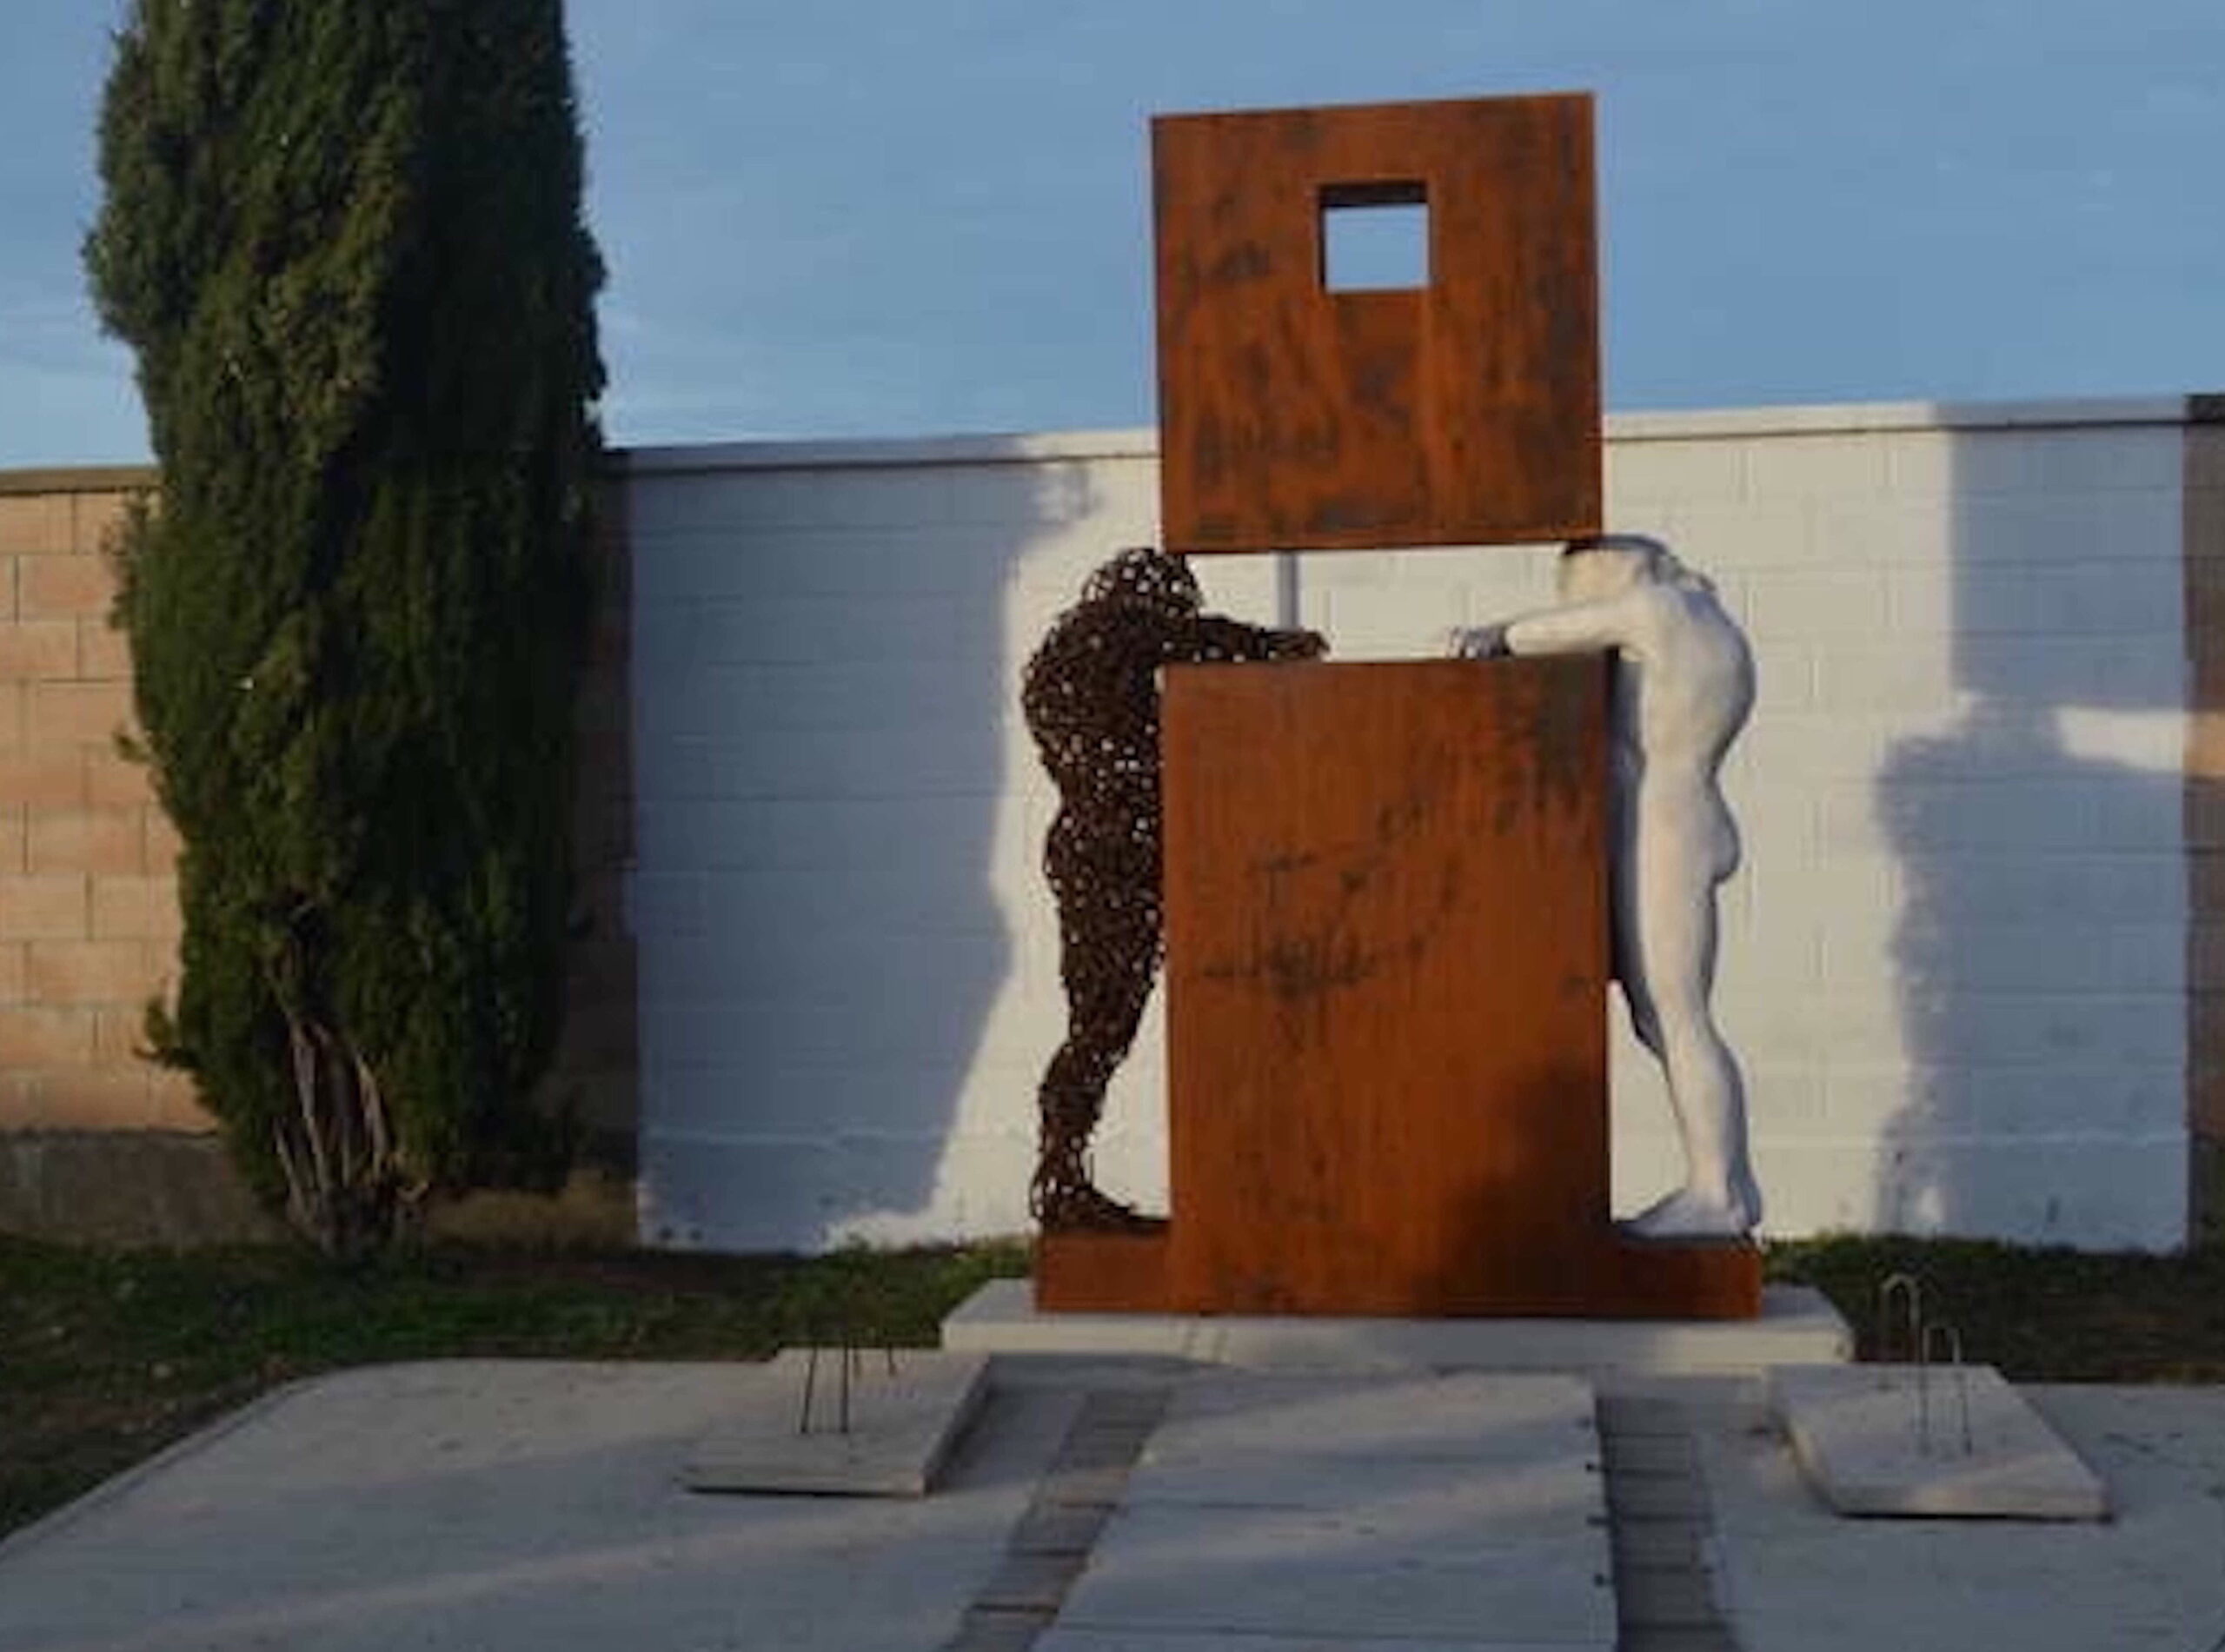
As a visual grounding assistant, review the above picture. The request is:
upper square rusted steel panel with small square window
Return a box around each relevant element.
[1152,93,1600,552]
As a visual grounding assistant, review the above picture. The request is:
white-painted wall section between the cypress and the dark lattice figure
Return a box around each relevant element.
[636,442,1093,1250]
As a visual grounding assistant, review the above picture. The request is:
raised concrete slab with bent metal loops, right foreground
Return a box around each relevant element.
[1769,1365,2109,1521]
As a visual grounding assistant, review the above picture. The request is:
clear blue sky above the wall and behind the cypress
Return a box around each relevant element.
[0,0,2225,467]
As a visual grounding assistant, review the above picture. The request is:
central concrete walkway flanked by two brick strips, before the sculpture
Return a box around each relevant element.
[946,1374,1699,1652]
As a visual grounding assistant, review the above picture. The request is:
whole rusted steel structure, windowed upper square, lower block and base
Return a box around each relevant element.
[1030,96,1760,1318]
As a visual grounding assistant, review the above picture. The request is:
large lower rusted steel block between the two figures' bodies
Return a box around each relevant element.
[1164,658,1757,1317]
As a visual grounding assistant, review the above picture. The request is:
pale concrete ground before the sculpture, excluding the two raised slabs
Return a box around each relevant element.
[0,1357,2225,1652]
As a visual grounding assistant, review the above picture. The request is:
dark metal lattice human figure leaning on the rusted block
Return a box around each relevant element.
[1021,547,1328,1230]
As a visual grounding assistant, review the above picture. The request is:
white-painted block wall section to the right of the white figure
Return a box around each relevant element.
[1613,401,2189,1247]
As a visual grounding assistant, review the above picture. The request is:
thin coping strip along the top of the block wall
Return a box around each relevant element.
[13,394,2225,496]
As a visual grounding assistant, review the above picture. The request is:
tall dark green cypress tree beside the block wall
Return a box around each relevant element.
[84,0,603,1254]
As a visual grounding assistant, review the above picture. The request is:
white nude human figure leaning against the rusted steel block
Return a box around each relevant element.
[1453,534,1763,1238]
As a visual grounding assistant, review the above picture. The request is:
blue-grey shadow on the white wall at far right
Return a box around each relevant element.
[1871,429,2187,1245]
